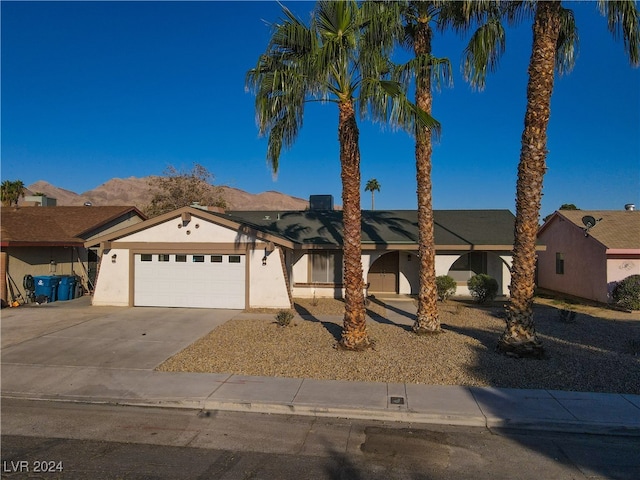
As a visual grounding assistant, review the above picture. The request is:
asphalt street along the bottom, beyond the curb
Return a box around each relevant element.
[2,399,640,480]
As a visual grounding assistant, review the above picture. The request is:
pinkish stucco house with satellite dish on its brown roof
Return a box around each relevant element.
[538,210,640,303]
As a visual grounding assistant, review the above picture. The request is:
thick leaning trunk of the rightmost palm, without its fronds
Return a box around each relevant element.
[498,2,560,358]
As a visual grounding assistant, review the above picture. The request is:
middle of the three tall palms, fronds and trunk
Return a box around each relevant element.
[367,0,495,334]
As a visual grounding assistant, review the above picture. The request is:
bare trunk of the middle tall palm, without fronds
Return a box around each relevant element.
[413,17,441,334]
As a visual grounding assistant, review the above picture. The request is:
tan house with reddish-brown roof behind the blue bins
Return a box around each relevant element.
[0,206,146,301]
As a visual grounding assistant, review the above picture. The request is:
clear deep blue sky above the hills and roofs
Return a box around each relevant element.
[1,1,640,215]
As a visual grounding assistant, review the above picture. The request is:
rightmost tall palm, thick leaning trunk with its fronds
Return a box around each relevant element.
[465,0,640,357]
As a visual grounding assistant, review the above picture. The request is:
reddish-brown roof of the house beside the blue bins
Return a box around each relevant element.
[0,206,145,246]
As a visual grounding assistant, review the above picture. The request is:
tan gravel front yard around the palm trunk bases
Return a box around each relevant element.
[158,300,640,394]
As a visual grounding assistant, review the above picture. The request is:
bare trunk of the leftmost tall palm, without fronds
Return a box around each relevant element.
[338,102,371,350]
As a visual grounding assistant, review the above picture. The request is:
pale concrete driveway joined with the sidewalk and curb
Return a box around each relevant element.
[2,299,640,436]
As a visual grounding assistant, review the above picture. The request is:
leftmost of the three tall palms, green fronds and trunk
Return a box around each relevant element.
[247,1,436,350]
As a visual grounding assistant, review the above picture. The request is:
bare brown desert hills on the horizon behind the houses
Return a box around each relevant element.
[26,177,309,210]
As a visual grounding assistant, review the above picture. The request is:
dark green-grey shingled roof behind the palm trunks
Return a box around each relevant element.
[224,210,515,249]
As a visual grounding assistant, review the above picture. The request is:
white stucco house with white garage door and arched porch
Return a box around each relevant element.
[85,202,515,308]
